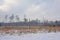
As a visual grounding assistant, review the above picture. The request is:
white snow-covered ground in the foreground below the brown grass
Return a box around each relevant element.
[0,32,60,40]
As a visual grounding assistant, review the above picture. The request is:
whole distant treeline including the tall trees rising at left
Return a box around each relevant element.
[0,14,60,26]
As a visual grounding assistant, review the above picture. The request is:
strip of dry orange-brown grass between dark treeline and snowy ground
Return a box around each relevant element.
[0,26,60,31]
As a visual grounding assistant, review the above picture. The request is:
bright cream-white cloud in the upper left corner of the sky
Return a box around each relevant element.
[0,0,23,12]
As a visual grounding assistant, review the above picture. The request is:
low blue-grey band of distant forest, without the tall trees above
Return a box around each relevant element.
[0,20,60,26]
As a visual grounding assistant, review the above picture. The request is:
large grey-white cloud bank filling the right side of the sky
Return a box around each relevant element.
[25,0,60,20]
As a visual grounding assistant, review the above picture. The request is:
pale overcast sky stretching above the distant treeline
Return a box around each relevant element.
[0,0,60,20]
